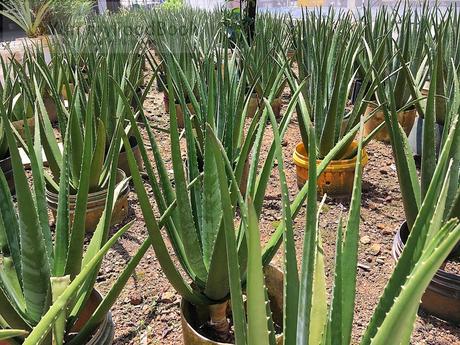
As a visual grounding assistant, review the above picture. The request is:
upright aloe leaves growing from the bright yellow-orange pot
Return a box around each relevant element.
[291,8,381,159]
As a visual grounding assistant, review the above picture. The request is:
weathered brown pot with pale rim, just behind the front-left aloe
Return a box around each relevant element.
[46,169,129,232]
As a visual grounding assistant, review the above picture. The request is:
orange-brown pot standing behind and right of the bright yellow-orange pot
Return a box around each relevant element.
[364,104,417,143]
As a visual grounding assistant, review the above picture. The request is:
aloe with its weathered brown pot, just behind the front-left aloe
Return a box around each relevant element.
[27,71,129,231]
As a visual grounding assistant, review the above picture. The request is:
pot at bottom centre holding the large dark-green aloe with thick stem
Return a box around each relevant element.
[181,266,283,345]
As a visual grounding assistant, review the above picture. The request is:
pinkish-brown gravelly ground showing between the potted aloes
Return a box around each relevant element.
[93,68,460,345]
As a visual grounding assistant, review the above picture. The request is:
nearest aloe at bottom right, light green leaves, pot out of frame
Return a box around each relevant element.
[226,117,460,345]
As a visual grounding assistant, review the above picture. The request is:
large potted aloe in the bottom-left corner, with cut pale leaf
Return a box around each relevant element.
[0,96,131,345]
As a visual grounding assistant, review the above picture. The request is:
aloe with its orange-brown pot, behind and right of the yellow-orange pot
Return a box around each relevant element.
[359,3,430,142]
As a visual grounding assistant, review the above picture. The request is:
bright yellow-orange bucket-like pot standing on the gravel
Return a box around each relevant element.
[293,141,368,197]
